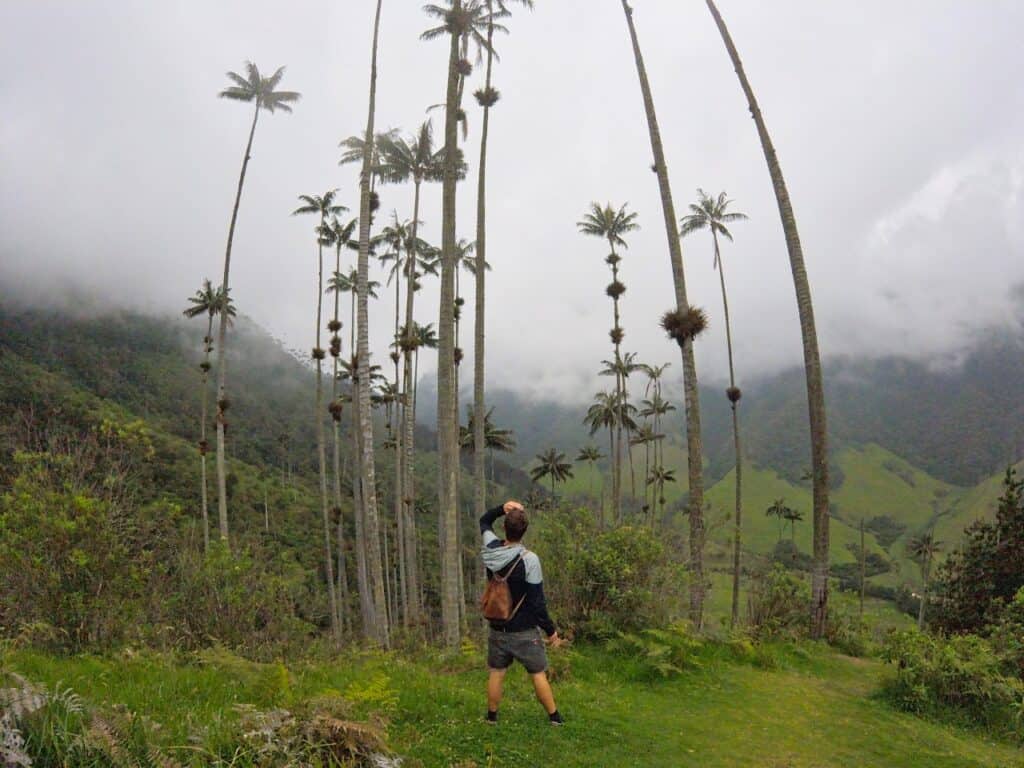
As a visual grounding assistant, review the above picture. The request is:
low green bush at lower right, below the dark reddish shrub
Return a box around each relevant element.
[883,630,1024,727]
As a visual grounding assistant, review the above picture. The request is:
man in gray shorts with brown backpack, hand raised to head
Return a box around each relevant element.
[480,501,564,725]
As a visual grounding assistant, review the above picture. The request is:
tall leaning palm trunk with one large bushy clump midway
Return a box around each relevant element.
[623,0,706,629]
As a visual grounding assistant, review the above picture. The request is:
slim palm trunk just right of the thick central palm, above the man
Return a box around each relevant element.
[473,0,495,528]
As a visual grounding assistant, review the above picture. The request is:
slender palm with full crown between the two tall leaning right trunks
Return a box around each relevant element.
[679,188,746,626]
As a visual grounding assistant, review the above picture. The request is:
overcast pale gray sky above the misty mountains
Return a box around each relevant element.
[0,0,1024,398]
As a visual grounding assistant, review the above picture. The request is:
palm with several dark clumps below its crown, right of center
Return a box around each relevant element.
[577,203,640,520]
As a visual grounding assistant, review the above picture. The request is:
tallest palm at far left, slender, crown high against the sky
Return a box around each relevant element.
[217,61,301,543]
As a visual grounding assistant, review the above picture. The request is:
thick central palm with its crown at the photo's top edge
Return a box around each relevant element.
[421,0,499,649]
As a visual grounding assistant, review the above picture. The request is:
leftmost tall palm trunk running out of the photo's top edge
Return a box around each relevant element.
[356,0,390,648]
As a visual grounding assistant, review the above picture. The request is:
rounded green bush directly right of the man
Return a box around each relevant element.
[537,513,686,639]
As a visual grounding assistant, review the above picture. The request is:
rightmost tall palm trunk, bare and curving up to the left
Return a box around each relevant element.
[707,0,828,637]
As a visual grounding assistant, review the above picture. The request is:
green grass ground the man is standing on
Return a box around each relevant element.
[6,645,1024,768]
